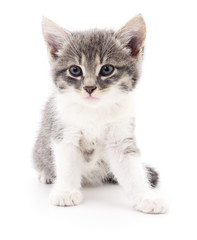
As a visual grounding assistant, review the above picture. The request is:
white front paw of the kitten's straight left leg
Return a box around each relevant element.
[50,189,82,207]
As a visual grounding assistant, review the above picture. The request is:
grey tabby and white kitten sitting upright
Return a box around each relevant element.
[33,15,167,213]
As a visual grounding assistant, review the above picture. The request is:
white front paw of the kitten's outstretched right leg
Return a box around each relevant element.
[133,195,168,214]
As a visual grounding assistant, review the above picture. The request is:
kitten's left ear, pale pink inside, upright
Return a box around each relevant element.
[42,17,71,59]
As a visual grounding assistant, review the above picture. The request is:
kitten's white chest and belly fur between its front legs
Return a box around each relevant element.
[55,93,134,183]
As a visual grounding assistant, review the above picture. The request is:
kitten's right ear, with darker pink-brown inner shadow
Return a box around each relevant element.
[116,15,146,57]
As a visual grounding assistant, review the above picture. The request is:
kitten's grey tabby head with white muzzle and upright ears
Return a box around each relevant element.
[42,15,146,107]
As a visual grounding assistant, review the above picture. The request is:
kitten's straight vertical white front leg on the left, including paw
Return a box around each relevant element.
[50,140,82,206]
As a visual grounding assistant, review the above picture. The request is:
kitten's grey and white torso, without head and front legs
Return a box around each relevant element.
[34,92,137,185]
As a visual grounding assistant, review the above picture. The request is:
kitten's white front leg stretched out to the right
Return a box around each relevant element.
[107,129,167,213]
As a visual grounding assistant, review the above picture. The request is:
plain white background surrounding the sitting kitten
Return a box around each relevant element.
[0,0,197,240]
